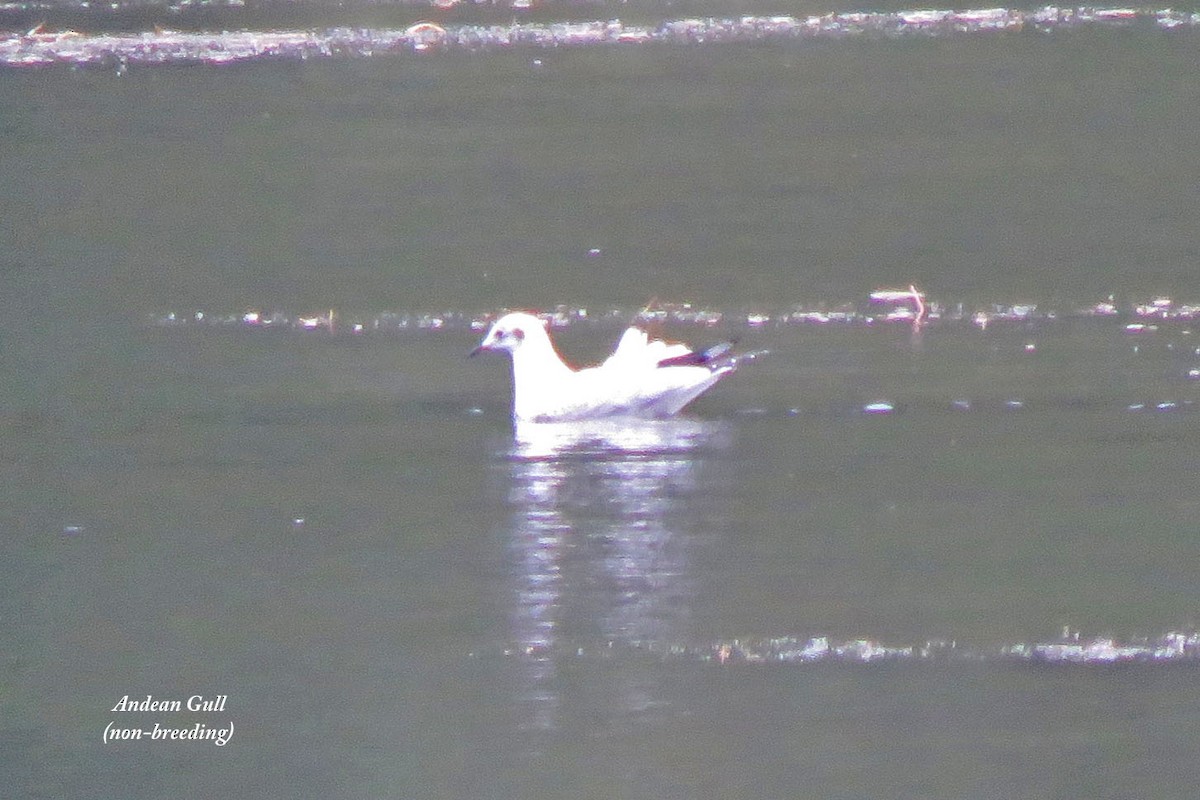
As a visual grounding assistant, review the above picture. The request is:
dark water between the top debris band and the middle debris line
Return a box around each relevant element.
[4,31,1200,312]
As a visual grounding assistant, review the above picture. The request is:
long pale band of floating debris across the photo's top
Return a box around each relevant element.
[0,6,1200,73]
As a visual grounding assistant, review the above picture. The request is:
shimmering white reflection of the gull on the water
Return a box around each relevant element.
[506,419,727,728]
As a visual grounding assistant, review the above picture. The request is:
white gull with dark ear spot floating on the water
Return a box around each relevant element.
[470,312,757,422]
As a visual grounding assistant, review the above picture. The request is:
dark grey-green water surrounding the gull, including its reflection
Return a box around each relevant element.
[0,21,1200,800]
